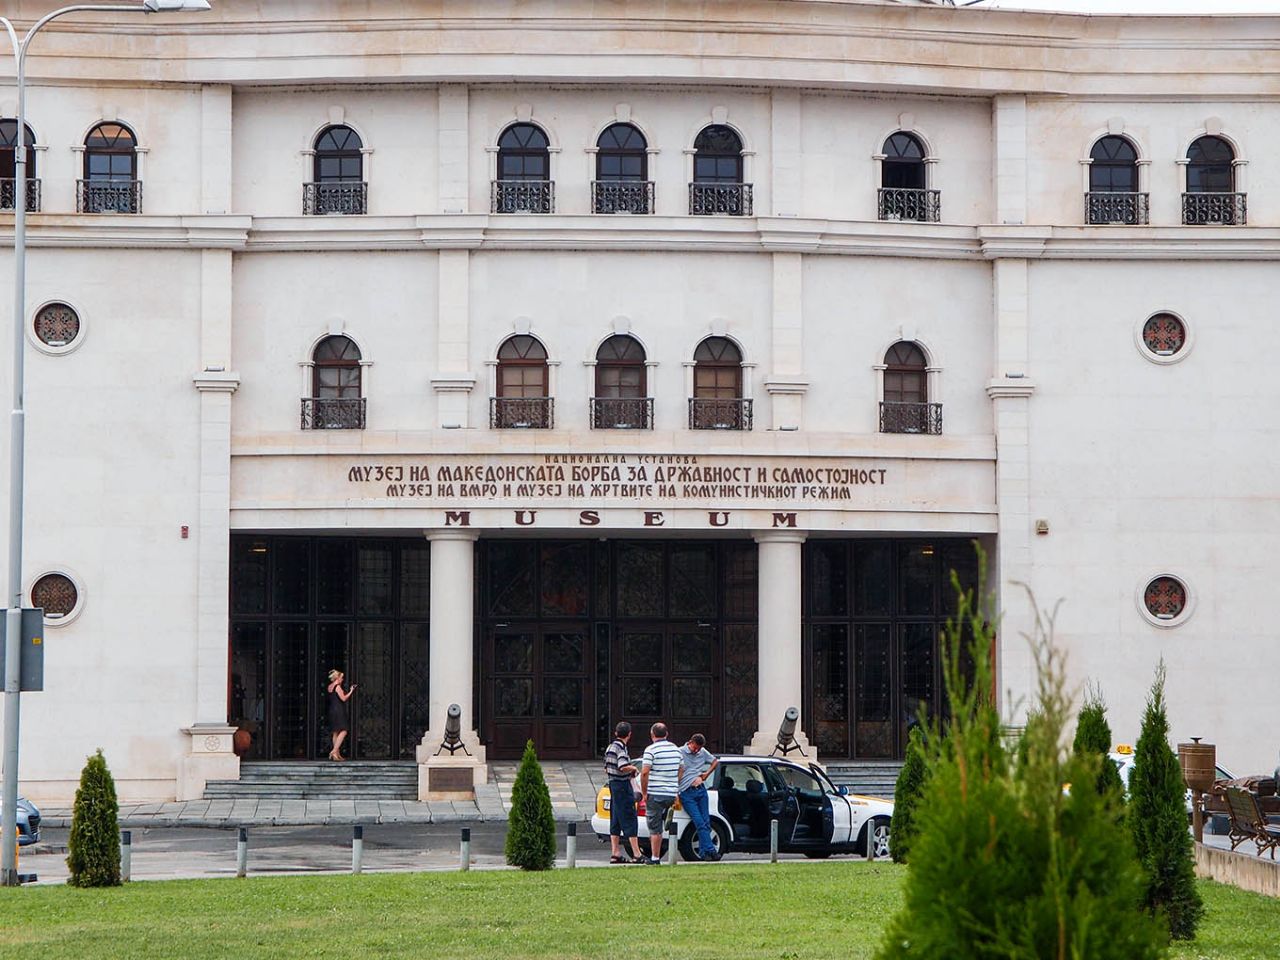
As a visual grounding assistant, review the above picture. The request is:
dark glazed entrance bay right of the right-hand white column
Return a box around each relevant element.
[803,538,978,760]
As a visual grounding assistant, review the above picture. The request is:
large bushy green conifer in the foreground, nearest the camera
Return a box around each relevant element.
[878,555,1167,960]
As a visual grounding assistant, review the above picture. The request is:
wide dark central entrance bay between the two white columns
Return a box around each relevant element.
[477,540,758,759]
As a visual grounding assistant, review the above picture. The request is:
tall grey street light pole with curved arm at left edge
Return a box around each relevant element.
[0,0,210,887]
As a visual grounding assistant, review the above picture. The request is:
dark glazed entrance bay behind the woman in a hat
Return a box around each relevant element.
[227,534,430,760]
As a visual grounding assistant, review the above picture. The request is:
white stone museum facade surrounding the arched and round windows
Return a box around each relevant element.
[0,0,1280,800]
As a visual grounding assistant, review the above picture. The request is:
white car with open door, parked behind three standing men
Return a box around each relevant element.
[591,756,893,860]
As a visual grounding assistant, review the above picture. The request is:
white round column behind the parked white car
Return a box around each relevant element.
[748,530,817,760]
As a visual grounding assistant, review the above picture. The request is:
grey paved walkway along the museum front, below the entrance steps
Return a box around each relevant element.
[41,760,604,827]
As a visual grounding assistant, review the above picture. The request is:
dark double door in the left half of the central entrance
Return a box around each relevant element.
[483,625,594,760]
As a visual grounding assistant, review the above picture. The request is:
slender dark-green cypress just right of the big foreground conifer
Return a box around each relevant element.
[1128,659,1204,940]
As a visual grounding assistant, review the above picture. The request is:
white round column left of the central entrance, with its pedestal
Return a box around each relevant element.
[417,530,488,800]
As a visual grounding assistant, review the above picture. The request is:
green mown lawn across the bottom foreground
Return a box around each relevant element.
[0,861,1280,960]
